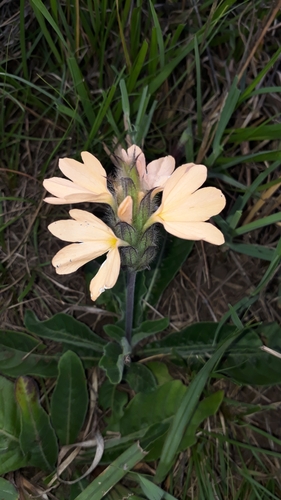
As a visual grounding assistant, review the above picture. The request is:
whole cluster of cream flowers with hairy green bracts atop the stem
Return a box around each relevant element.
[43,145,225,300]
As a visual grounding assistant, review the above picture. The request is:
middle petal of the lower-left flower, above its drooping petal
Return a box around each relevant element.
[52,242,108,274]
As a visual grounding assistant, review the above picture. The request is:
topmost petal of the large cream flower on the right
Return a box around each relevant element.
[162,163,207,207]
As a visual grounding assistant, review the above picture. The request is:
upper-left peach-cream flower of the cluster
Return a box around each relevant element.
[43,151,115,207]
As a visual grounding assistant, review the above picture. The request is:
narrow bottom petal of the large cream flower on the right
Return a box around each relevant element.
[159,221,224,245]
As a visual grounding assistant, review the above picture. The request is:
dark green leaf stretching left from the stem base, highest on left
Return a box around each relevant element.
[24,311,106,352]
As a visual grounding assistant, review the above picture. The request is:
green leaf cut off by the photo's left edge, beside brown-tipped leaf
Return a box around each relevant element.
[0,376,27,474]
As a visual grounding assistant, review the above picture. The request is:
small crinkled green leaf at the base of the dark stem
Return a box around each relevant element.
[99,337,131,384]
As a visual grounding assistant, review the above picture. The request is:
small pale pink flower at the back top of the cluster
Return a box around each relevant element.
[121,144,176,194]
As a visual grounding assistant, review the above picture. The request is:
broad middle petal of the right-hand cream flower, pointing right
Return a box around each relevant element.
[160,187,226,222]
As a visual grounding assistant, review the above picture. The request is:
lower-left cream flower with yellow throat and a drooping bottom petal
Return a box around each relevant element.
[48,209,128,300]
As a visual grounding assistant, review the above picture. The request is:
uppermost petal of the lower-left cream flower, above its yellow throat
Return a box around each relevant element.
[48,209,118,244]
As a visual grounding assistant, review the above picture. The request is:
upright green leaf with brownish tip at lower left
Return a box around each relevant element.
[16,377,58,471]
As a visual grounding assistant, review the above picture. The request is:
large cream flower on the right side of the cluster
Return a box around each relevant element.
[144,163,226,245]
